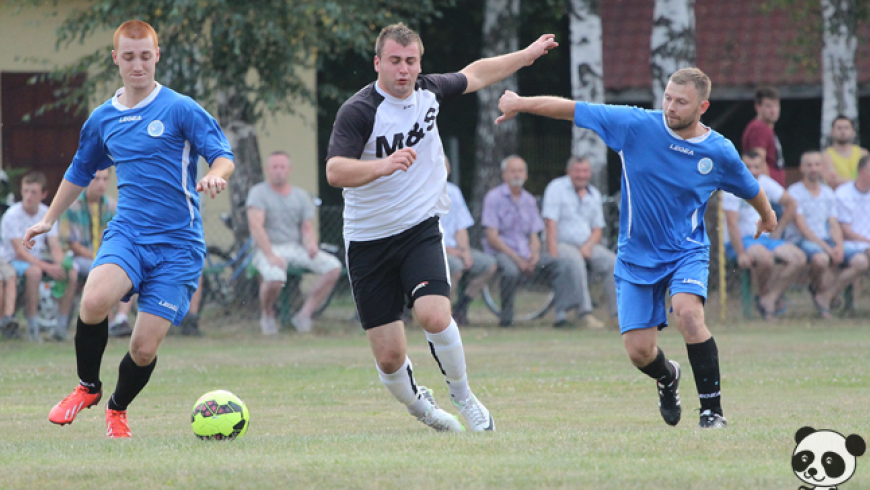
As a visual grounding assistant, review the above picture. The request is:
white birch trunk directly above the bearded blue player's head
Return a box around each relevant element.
[649,0,696,109]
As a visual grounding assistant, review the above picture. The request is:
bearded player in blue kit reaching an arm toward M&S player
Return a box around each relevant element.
[496,68,776,428]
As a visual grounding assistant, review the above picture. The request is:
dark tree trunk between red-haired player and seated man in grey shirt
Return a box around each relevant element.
[217,92,263,246]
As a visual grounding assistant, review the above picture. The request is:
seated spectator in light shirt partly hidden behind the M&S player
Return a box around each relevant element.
[441,157,495,325]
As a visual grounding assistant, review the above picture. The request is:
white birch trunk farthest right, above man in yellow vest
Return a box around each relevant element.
[821,0,858,148]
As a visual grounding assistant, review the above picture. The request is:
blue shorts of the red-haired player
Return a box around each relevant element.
[92,230,203,325]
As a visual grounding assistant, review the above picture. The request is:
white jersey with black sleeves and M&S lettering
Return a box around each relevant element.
[326,73,468,242]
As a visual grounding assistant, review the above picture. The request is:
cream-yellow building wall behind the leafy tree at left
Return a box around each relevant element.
[0,0,318,249]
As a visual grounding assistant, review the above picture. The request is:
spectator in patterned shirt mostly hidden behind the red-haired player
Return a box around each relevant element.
[61,169,133,337]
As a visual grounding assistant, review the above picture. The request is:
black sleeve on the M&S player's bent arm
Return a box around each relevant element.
[326,84,383,161]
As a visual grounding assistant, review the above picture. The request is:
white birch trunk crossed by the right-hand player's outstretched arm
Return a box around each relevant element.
[568,0,608,195]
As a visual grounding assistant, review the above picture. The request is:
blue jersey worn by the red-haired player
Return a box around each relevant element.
[64,84,233,252]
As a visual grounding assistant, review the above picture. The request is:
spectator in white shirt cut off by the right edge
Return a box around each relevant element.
[834,155,870,264]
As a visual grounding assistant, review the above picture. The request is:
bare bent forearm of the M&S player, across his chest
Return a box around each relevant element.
[326,148,417,187]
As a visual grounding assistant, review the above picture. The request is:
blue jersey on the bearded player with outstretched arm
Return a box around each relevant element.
[574,102,759,283]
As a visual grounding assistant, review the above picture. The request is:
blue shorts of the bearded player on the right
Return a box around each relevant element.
[616,257,710,334]
